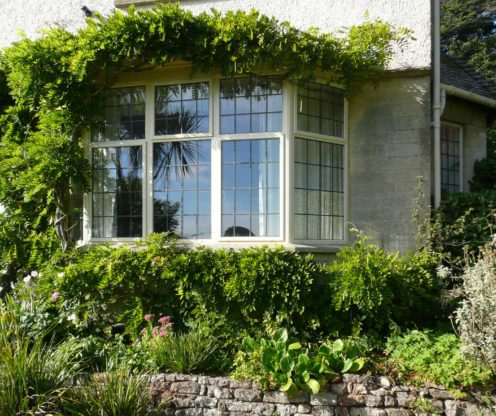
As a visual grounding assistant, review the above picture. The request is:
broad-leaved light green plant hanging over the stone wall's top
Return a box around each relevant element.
[235,328,364,396]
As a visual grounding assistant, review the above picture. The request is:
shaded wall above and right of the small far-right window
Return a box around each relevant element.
[442,97,488,191]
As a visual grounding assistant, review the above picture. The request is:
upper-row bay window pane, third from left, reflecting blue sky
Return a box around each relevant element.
[220,77,282,134]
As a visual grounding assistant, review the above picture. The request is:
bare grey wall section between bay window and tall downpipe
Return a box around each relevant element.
[349,76,431,252]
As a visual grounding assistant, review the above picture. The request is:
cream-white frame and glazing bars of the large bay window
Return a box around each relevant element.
[81,72,349,251]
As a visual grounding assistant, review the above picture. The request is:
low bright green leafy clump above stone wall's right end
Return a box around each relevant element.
[387,330,493,389]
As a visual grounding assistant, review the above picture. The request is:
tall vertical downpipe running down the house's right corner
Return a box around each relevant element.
[432,0,443,208]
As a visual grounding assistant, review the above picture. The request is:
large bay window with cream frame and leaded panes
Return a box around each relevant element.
[85,76,346,244]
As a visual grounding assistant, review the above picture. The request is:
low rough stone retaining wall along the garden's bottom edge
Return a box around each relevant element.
[150,374,496,416]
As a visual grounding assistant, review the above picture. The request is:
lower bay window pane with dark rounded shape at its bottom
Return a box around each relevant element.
[222,139,280,237]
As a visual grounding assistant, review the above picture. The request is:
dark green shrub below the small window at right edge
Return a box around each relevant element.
[431,191,496,271]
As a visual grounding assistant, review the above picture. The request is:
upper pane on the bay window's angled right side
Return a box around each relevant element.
[297,82,344,137]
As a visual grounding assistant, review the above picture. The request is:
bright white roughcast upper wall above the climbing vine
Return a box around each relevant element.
[0,0,431,69]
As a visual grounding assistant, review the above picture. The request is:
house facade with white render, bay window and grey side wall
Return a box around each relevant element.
[0,0,496,258]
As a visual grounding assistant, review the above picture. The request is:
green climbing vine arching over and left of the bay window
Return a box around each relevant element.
[0,4,408,280]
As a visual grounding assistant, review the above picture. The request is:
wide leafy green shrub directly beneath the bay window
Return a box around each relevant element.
[34,235,318,346]
